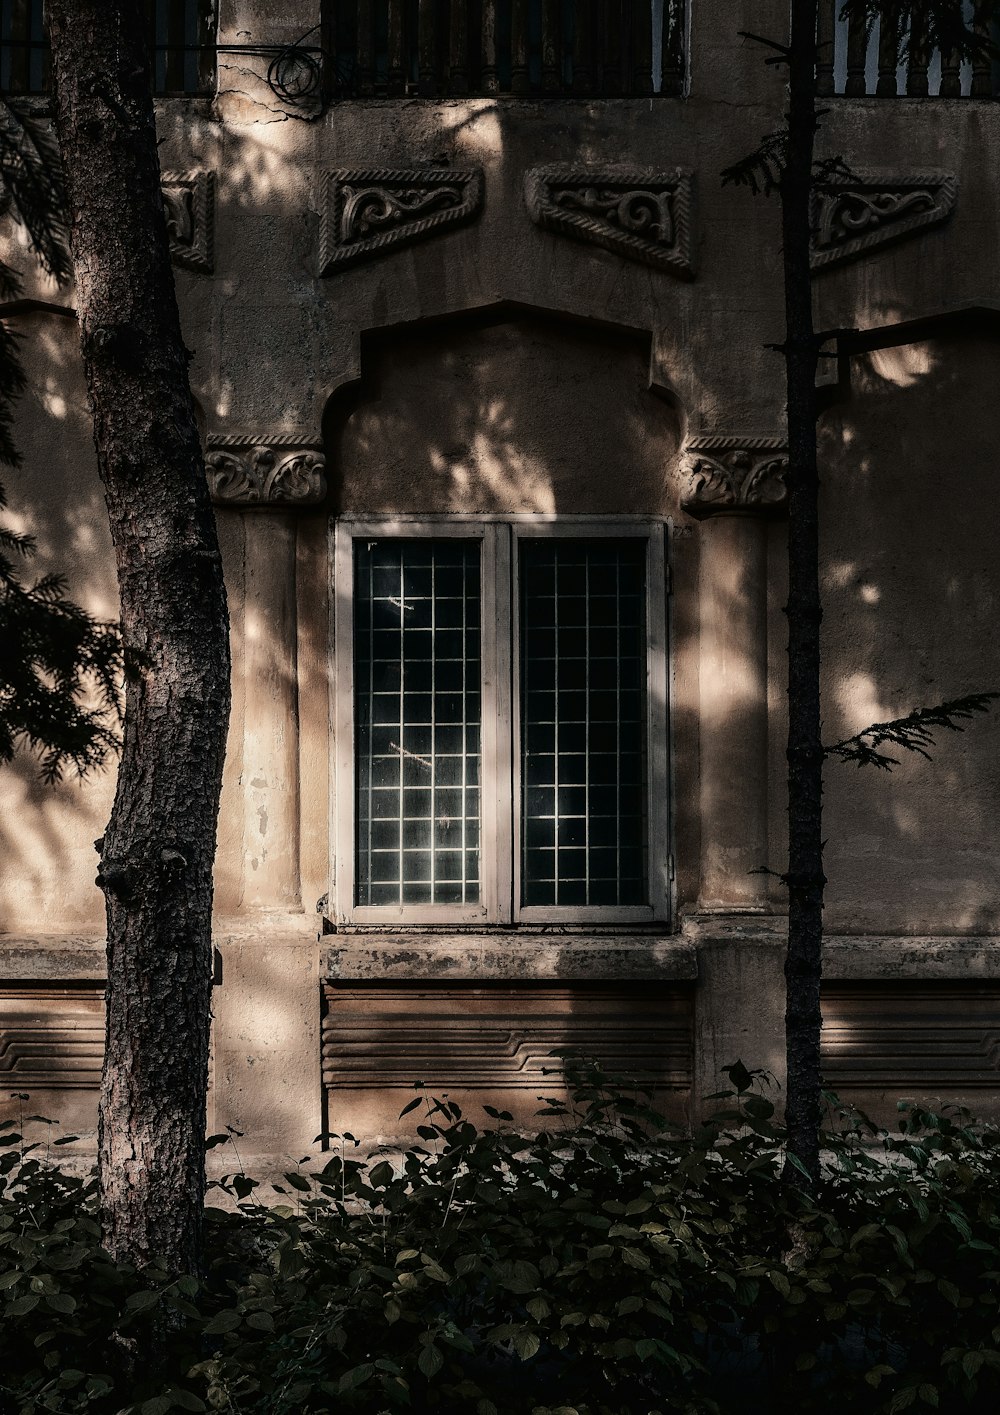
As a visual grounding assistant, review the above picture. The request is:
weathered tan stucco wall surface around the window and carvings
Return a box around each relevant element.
[0,0,1000,1155]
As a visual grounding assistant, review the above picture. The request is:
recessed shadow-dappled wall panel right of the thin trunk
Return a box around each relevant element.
[820,328,1000,934]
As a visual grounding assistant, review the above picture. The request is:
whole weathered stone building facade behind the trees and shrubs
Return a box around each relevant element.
[0,0,1000,1163]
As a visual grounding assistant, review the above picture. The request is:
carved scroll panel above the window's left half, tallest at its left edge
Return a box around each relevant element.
[320,167,482,275]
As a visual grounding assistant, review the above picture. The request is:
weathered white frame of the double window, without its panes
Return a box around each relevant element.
[330,515,672,928]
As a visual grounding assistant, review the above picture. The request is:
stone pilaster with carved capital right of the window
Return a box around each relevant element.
[682,437,788,911]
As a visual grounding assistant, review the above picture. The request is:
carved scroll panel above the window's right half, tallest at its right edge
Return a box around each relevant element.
[525,163,694,280]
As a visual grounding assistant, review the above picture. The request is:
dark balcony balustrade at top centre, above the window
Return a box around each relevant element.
[322,0,686,99]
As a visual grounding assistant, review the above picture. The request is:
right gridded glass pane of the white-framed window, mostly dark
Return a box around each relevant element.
[521,538,646,906]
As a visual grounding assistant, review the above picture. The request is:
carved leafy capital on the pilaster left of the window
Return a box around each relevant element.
[205,433,327,511]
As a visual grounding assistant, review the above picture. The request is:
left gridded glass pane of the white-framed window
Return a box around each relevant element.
[354,538,482,906]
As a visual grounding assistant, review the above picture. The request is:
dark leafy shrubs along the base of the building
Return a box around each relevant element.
[0,1061,1000,1415]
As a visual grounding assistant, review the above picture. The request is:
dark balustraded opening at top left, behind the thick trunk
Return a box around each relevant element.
[0,0,215,95]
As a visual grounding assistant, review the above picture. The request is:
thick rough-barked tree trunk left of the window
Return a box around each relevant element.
[47,0,229,1274]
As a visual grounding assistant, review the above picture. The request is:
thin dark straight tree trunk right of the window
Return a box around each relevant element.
[781,0,826,1182]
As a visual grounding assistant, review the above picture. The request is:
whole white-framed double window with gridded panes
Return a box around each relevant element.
[335,518,669,924]
